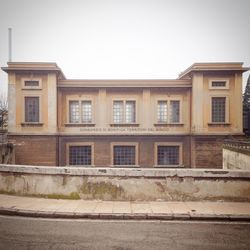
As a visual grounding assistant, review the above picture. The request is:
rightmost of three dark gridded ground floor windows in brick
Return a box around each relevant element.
[157,145,180,165]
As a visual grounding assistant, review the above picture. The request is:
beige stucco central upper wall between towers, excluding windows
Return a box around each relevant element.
[58,88,191,135]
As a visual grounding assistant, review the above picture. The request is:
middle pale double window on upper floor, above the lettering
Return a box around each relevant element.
[113,101,136,123]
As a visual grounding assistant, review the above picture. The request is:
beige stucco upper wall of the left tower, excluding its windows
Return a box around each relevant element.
[9,73,57,133]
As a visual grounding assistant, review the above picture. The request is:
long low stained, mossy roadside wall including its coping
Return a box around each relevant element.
[0,165,250,202]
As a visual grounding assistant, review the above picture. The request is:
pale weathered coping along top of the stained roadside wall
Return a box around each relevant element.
[0,164,250,179]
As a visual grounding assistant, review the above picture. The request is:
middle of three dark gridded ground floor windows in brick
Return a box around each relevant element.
[113,146,136,165]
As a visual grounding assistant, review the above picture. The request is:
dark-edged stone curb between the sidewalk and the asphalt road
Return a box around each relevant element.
[0,207,250,221]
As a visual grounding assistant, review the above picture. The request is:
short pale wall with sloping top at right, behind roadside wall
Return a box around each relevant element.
[223,148,250,170]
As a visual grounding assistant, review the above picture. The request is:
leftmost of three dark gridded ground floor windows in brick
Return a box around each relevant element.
[69,146,92,165]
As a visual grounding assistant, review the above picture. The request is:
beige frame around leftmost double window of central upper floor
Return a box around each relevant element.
[65,97,95,126]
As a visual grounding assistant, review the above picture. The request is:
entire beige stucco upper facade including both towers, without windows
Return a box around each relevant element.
[9,67,242,135]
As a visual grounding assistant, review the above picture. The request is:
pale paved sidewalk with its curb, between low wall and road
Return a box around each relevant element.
[0,195,250,221]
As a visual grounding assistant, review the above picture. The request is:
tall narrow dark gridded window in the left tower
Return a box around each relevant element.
[24,96,39,122]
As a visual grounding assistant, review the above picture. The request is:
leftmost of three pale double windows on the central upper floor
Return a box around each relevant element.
[69,101,92,123]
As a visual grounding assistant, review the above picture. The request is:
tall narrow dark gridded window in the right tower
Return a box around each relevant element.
[212,97,226,123]
